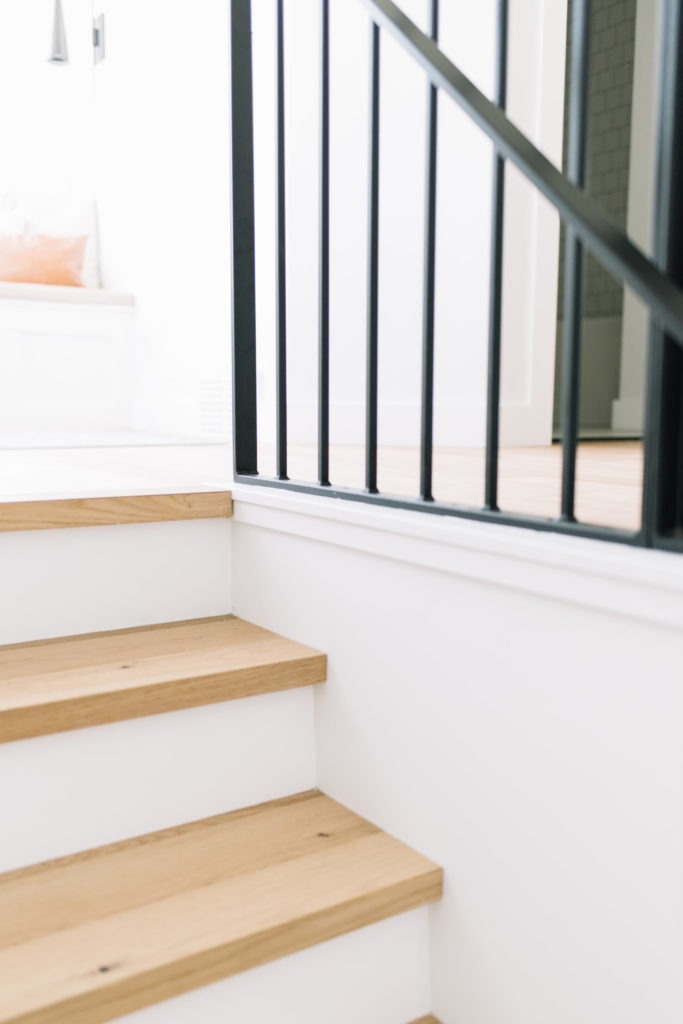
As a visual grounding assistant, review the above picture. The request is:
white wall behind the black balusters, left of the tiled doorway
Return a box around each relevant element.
[253,0,566,444]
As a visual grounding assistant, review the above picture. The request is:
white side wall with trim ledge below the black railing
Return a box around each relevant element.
[233,487,683,1024]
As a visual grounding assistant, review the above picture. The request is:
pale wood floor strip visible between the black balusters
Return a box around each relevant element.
[259,440,643,529]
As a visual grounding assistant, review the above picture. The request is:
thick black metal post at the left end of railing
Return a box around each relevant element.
[230,0,257,474]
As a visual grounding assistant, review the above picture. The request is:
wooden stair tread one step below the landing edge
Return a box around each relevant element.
[0,615,327,742]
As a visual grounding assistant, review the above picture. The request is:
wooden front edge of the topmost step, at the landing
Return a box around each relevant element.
[0,490,232,532]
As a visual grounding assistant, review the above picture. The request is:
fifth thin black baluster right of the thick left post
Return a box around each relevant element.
[484,0,509,512]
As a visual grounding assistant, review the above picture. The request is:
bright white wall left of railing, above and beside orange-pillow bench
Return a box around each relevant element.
[0,0,229,440]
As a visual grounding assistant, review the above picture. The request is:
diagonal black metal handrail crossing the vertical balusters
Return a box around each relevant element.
[361,0,683,347]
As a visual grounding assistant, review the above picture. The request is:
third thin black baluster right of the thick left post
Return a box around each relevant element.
[366,23,380,495]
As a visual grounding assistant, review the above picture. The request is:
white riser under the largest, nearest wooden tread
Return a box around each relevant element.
[114,907,430,1024]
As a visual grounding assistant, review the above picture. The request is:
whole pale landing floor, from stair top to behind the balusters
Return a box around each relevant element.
[0,441,642,529]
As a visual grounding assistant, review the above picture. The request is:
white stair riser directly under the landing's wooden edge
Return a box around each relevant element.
[0,519,231,656]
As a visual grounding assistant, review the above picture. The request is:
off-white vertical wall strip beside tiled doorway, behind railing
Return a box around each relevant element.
[499,0,567,444]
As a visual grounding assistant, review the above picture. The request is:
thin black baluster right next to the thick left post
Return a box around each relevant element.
[275,0,288,480]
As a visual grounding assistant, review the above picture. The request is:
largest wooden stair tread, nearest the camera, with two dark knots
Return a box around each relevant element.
[0,792,441,1024]
